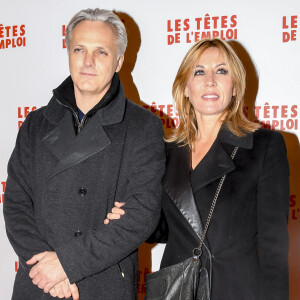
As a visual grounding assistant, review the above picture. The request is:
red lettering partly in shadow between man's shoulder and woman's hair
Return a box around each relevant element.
[143,101,179,129]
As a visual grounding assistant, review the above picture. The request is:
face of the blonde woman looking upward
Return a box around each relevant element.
[184,47,235,116]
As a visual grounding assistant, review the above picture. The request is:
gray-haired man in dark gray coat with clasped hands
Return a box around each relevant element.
[4,9,165,300]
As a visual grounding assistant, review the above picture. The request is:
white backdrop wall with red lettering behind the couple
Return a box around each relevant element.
[0,0,300,300]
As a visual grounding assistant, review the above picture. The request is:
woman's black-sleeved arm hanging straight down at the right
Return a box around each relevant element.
[257,131,289,300]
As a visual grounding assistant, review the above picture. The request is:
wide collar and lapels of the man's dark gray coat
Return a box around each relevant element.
[43,79,126,176]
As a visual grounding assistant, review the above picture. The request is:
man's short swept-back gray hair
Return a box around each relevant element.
[66,8,127,56]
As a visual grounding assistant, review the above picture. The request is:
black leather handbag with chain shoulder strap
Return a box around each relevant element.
[144,147,238,300]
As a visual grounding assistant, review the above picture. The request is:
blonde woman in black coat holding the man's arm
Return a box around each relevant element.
[105,39,289,300]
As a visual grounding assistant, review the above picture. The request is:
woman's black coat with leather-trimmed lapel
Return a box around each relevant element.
[155,128,289,300]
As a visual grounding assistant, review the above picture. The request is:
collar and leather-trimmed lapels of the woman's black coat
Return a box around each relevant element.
[163,126,253,241]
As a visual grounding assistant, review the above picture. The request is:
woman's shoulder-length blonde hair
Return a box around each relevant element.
[167,38,259,148]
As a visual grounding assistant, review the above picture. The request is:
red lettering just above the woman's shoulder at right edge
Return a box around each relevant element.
[245,102,299,131]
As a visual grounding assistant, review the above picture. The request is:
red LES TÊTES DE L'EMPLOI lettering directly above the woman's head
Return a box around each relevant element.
[167,14,238,45]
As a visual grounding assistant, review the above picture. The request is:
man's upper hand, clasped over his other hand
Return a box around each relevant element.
[26,251,67,293]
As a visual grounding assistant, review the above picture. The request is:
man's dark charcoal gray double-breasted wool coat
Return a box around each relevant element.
[4,80,165,300]
